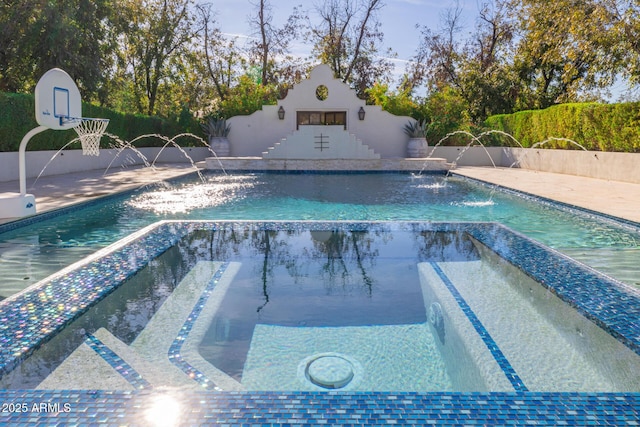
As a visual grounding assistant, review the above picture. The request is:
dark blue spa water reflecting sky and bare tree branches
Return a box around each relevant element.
[190,225,479,380]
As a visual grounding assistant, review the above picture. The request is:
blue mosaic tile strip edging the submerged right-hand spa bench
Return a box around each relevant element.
[430,261,529,391]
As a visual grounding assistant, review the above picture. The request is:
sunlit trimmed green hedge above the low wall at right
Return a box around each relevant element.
[485,102,640,153]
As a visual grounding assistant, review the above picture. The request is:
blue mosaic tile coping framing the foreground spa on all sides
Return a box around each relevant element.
[0,221,640,425]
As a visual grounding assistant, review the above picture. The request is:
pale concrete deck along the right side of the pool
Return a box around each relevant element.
[453,167,640,222]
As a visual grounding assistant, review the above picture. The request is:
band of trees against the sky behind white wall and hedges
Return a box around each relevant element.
[0,0,640,129]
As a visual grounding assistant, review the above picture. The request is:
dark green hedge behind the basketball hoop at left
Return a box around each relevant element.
[0,93,204,151]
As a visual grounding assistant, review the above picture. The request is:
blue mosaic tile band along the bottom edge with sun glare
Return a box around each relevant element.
[0,391,640,427]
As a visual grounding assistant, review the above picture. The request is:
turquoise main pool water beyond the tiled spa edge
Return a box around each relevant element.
[0,173,640,298]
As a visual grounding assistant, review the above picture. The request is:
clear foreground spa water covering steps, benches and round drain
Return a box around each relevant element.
[5,221,640,392]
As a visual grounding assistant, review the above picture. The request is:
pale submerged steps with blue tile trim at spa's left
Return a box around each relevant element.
[38,261,243,390]
